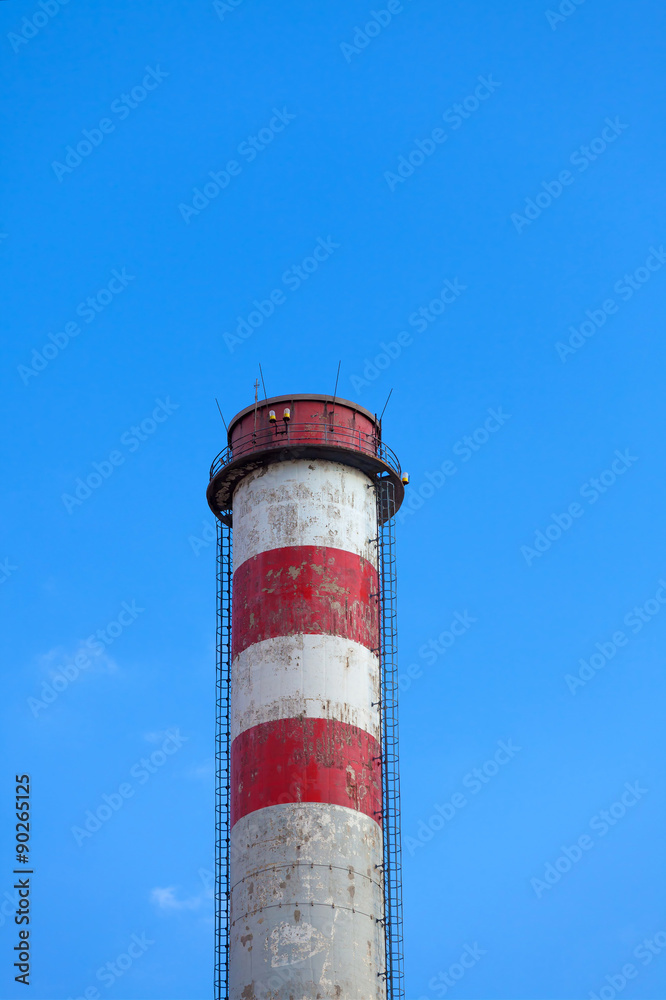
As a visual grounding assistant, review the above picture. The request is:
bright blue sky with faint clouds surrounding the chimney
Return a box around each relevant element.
[0,0,666,1000]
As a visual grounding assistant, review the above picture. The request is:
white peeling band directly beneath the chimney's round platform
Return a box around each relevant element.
[233,459,377,570]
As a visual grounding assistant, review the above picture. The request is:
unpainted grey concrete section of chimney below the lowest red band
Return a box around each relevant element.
[230,803,386,1000]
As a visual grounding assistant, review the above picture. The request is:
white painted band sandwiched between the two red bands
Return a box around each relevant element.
[231,635,380,740]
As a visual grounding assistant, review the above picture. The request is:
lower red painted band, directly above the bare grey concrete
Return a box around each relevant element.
[231,719,382,825]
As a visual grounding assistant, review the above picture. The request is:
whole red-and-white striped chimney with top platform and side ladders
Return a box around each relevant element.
[207,395,406,1000]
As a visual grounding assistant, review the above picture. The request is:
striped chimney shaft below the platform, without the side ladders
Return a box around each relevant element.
[230,459,386,1000]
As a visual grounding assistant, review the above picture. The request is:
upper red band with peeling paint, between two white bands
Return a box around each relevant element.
[232,545,379,656]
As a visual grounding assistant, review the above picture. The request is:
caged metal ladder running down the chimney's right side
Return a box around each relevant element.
[375,476,405,1000]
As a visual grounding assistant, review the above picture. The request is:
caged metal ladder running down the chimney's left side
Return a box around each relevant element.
[215,512,232,1000]
